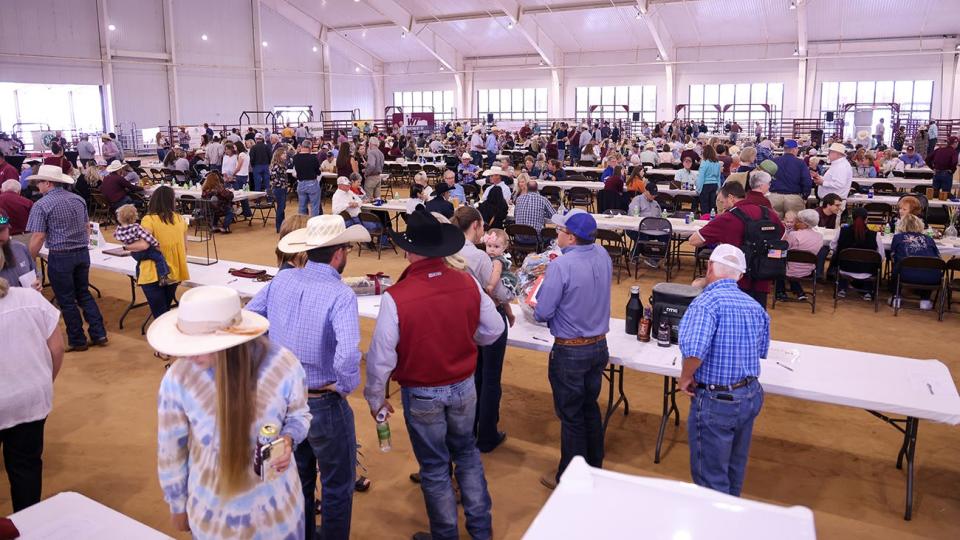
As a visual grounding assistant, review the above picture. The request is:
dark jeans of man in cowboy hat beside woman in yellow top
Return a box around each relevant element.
[47,248,107,346]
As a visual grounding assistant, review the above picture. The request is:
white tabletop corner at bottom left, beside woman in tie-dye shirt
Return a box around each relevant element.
[10,491,173,540]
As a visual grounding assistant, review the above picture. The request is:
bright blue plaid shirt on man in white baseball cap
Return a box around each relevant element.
[680,279,770,385]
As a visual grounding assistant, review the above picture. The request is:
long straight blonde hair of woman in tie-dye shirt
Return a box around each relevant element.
[214,338,267,499]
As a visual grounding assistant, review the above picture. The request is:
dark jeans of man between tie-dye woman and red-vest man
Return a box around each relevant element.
[294,393,357,540]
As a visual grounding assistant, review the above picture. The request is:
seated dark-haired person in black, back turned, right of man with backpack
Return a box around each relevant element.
[830,206,884,302]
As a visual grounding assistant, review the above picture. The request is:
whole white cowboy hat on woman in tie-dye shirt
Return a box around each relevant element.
[147,286,268,357]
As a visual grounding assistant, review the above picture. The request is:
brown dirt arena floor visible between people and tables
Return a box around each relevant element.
[0,195,960,540]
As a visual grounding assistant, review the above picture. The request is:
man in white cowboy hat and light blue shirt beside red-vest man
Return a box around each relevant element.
[247,214,370,540]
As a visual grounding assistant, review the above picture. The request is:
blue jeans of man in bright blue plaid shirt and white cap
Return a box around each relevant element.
[687,380,763,497]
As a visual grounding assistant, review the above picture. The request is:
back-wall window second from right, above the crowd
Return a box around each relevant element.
[687,83,783,125]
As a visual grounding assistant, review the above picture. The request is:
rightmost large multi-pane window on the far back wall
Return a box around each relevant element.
[820,81,933,120]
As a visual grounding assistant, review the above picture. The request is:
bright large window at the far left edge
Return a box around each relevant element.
[0,83,103,141]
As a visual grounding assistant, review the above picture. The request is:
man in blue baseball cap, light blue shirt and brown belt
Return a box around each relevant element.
[534,209,613,489]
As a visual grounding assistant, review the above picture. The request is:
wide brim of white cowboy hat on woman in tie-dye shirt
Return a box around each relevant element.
[147,309,270,357]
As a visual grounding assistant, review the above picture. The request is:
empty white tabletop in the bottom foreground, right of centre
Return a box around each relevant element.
[523,456,817,540]
